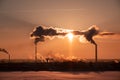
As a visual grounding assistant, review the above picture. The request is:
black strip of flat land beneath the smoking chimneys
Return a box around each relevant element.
[0,60,120,71]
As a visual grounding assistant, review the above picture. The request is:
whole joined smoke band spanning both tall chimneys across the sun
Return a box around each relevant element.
[30,25,114,45]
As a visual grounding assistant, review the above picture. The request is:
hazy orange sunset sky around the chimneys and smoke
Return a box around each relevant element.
[0,0,120,59]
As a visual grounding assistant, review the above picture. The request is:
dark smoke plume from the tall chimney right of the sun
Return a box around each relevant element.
[72,25,115,45]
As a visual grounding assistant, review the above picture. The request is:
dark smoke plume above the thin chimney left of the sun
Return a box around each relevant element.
[30,26,66,44]
